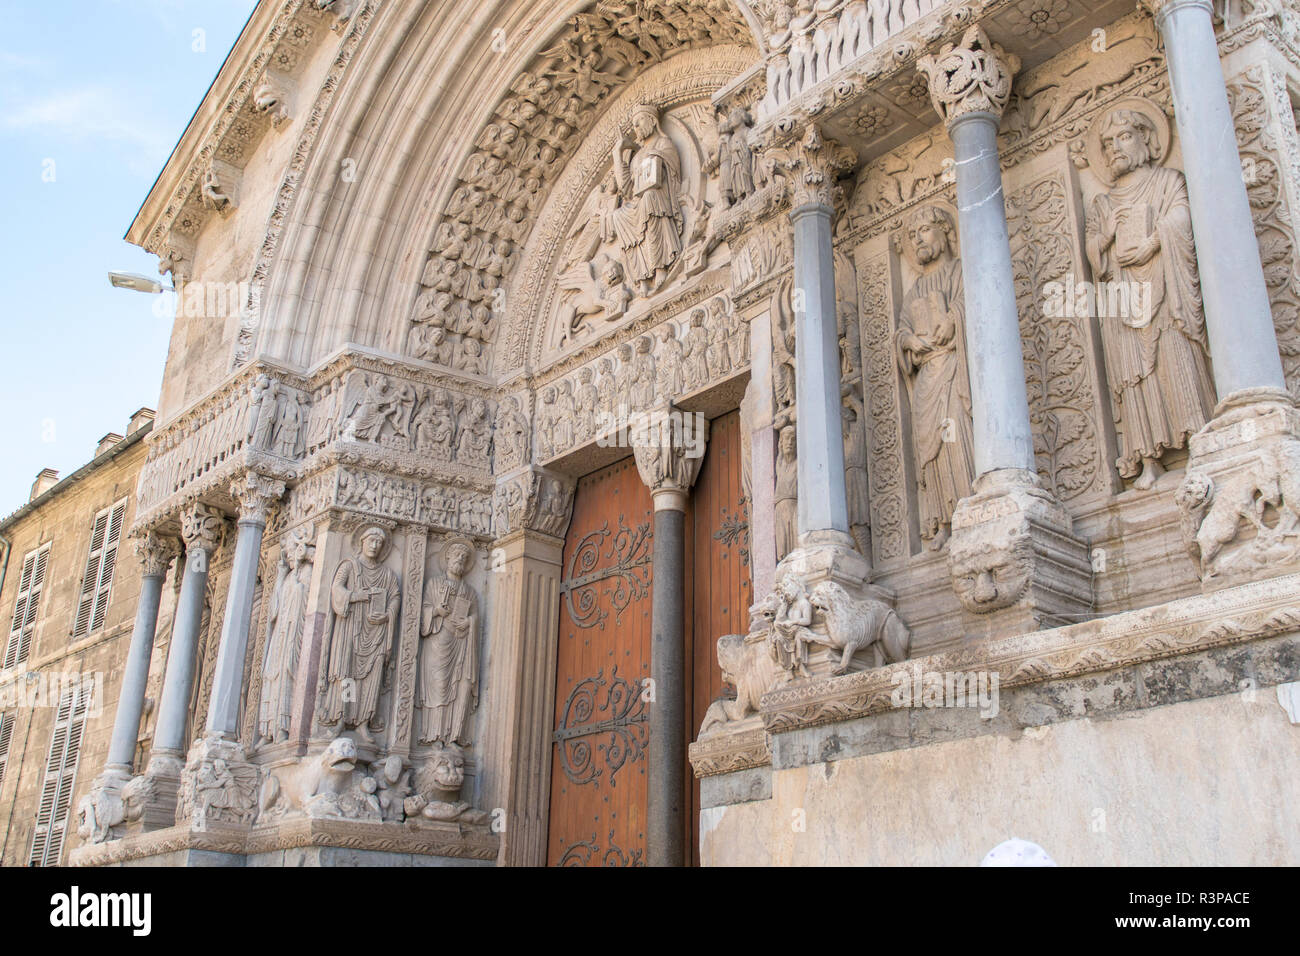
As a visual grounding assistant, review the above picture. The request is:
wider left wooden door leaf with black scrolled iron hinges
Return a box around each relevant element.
[547,458,654,866]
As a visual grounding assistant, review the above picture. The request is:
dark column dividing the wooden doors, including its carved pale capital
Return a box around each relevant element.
[634,410,709,866]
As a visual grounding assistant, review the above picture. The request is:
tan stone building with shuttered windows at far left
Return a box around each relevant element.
[0,408,170,866]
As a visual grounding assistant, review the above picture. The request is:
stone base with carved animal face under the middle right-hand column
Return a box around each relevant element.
[948,468,1092,637]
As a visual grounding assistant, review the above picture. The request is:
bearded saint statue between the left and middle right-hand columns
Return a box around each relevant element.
[896,206,975,551]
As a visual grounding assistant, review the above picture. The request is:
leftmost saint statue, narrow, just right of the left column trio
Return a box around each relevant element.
[257,524,316,744]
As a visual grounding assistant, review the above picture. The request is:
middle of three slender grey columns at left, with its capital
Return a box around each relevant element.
[150,505,225,771]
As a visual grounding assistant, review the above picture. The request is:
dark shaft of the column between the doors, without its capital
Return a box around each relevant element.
[646,496,686,866]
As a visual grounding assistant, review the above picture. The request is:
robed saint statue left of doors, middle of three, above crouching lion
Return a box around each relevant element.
[320,524,402,739]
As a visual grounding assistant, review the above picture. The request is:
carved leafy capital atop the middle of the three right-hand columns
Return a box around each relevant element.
[917,23,1021,125]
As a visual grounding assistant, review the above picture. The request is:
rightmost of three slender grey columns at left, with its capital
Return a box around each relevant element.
[208,472,285,740]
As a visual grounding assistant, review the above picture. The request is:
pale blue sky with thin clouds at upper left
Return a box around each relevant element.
[0,0,256,515]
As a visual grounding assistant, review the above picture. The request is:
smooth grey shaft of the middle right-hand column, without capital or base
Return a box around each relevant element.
[946,112,1036,479]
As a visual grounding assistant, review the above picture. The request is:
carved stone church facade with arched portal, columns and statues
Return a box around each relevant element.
[50,0,1300,865]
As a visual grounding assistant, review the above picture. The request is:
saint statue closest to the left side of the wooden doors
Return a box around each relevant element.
[416,541,478,745]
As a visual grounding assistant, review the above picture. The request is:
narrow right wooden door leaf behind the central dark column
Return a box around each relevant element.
[684,411,754,866]
